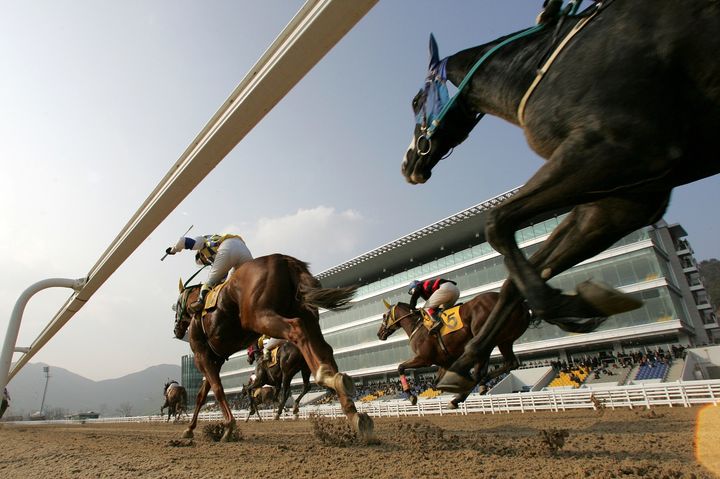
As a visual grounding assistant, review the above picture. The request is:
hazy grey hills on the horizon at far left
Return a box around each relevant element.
[6,363,180,416]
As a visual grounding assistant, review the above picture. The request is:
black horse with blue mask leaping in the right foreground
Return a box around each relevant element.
[401,0,720,392]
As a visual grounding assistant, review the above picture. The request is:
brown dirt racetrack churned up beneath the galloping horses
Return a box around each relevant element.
[0,406,720,479]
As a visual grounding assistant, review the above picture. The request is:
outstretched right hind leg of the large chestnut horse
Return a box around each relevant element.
[255,310,373,440]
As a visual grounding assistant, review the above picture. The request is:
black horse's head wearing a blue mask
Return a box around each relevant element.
[402,34,482,184]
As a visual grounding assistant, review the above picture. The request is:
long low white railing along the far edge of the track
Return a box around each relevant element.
[8,380,720,425]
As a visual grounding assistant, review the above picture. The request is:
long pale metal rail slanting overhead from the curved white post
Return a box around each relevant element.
[0,0,377,389]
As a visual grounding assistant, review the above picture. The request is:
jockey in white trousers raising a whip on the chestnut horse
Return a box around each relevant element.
[165,235,253,313]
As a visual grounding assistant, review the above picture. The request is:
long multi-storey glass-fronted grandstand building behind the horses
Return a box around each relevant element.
[182,190,720,400]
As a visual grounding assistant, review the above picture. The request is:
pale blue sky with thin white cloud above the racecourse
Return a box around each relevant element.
[0,0,720,380]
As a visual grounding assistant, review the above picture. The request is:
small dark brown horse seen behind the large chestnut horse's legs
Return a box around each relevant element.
[245,341,310,421]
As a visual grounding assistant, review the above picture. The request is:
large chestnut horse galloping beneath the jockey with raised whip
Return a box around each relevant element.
[174,254,373,441]
